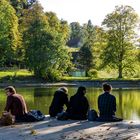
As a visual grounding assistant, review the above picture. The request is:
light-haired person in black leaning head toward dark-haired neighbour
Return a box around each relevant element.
[49,87,68,117]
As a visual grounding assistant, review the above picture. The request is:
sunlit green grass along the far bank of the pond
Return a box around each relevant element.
[0,69,140,83]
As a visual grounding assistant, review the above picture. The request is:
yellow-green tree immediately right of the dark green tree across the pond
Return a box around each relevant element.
[46,12,72,80]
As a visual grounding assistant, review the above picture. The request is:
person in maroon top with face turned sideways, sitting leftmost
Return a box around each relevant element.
[5,86,27,120]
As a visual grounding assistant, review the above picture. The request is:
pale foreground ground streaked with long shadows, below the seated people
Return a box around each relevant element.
[0,116,140,140]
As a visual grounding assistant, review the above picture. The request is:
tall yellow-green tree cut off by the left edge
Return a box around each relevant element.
[0,0,20,66]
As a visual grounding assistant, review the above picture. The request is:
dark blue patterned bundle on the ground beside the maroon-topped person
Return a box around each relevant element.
[27,110,45,121]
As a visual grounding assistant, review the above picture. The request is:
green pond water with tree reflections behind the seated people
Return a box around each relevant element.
[0,87,140,120]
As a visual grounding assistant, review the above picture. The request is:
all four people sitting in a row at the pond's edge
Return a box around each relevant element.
[1,83,122,122]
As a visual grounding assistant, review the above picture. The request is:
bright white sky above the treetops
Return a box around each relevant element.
[39,0,140,26]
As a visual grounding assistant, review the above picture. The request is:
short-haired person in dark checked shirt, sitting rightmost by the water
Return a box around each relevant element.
[97,83,123,121]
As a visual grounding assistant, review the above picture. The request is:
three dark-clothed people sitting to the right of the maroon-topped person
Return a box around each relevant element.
[49,83,122,121]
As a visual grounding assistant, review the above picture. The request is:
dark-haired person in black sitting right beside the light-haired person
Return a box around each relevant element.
[66,86,89,120]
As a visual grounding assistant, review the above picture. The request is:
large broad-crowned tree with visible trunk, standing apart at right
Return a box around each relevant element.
[102,5,138,78]
